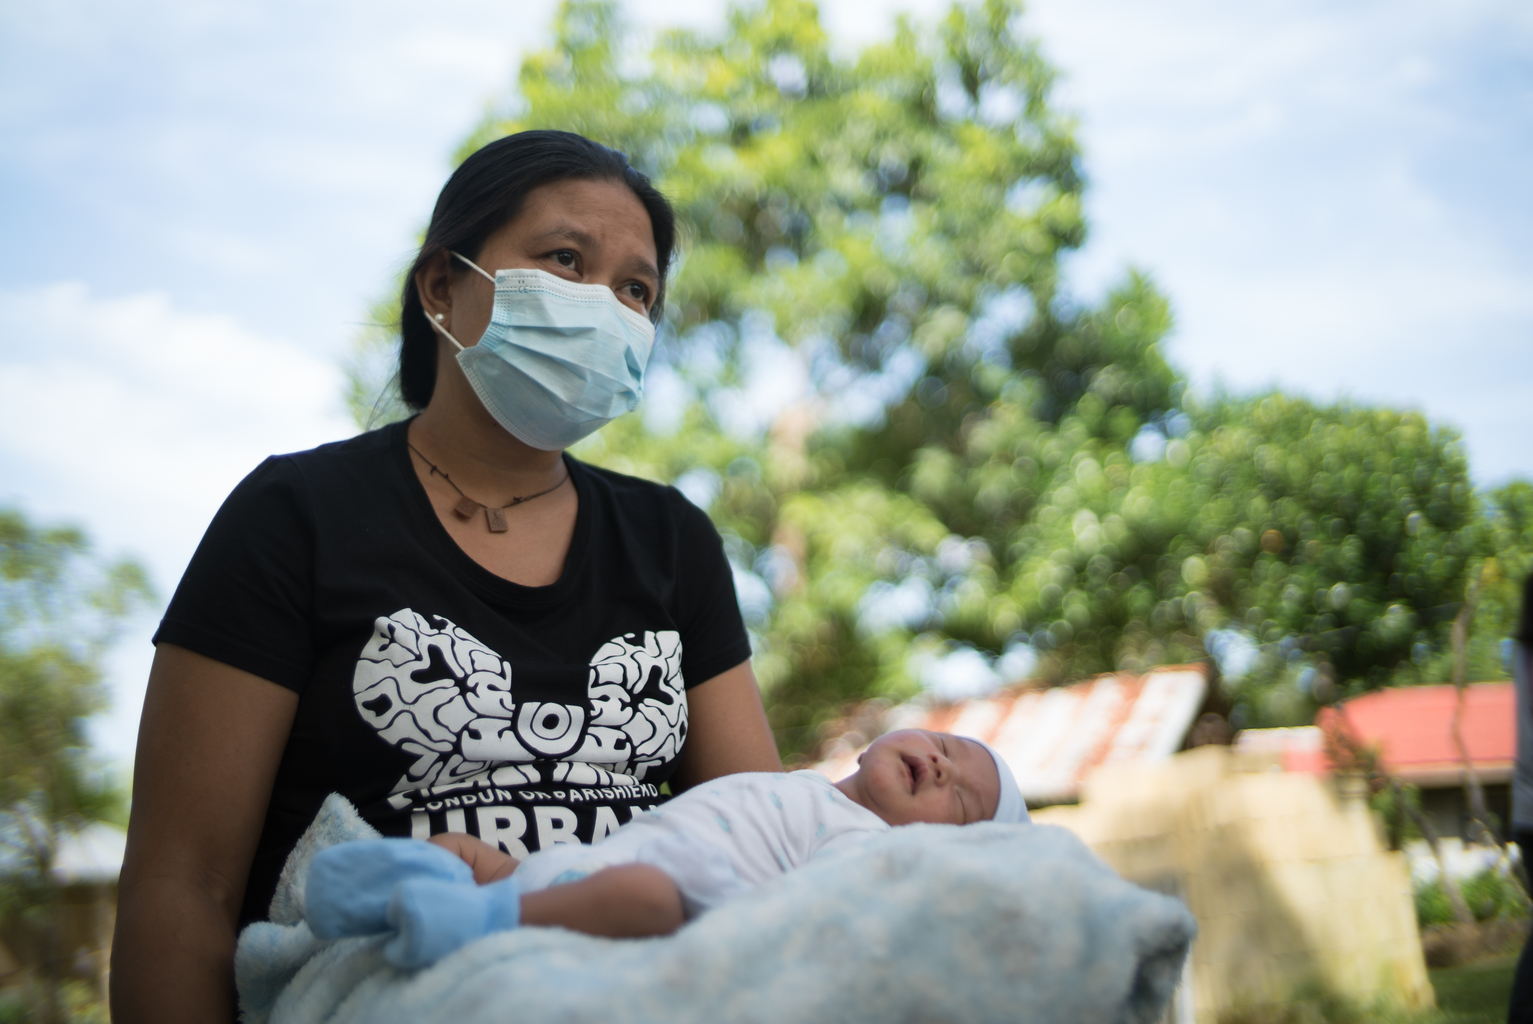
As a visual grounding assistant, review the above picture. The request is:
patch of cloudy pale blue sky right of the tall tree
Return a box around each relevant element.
[1027,0,1533,483]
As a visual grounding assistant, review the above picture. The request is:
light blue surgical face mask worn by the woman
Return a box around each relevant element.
[426,253,655,452]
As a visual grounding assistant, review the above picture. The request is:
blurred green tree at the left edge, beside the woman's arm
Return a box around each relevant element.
[0,509,152,1021]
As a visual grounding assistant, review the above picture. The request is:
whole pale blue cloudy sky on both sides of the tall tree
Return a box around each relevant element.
[0,0,1533,760]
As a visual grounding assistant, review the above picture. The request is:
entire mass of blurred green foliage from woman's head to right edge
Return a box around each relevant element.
[350,0,1533,754]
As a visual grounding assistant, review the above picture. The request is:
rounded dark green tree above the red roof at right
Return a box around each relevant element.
[1091,394,1479,725]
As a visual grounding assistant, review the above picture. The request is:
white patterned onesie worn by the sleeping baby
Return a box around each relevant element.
[515,771,889,918]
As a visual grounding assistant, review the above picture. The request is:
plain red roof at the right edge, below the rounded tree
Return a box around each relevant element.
[1331,682,1518,786]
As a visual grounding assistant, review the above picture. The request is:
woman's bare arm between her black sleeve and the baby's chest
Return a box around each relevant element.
[671,661,782,793]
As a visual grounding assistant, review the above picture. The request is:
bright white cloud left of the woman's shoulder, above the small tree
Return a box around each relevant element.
[0,282,354,772]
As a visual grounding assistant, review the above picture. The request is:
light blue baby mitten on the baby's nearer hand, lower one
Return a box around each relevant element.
[383,875,521,970]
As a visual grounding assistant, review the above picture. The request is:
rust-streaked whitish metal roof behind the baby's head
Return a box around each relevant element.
[814,665,1208,806]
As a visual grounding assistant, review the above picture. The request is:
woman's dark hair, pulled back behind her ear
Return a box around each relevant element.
[399,132,676,409]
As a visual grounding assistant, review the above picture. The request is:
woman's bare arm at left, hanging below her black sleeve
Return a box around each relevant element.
[112,644,297,1024]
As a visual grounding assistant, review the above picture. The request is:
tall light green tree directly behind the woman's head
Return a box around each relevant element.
[356,0,1176,748]
